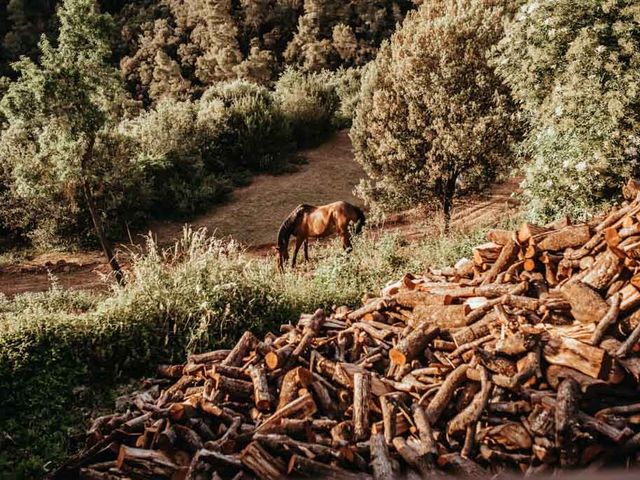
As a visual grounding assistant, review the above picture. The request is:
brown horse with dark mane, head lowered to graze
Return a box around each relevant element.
[276,202,365,271]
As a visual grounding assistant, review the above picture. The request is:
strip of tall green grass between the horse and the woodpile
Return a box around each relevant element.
[0,219,516,478]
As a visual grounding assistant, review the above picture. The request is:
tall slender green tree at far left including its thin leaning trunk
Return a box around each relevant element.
[0,0,123,282]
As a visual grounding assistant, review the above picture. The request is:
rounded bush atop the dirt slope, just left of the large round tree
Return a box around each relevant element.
[275,68,339,147]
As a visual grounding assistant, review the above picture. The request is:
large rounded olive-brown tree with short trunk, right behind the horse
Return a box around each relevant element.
[351,0,518,228]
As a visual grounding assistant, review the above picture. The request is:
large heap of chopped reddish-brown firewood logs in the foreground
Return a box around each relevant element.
[57,185,640,480]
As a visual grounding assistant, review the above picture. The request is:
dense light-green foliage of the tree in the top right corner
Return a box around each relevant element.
[495,0,640,221]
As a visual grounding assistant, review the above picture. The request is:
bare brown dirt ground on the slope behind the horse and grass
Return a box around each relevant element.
[0,131,518,296]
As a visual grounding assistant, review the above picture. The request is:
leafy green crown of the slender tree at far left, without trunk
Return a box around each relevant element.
[0,0,139,248]
